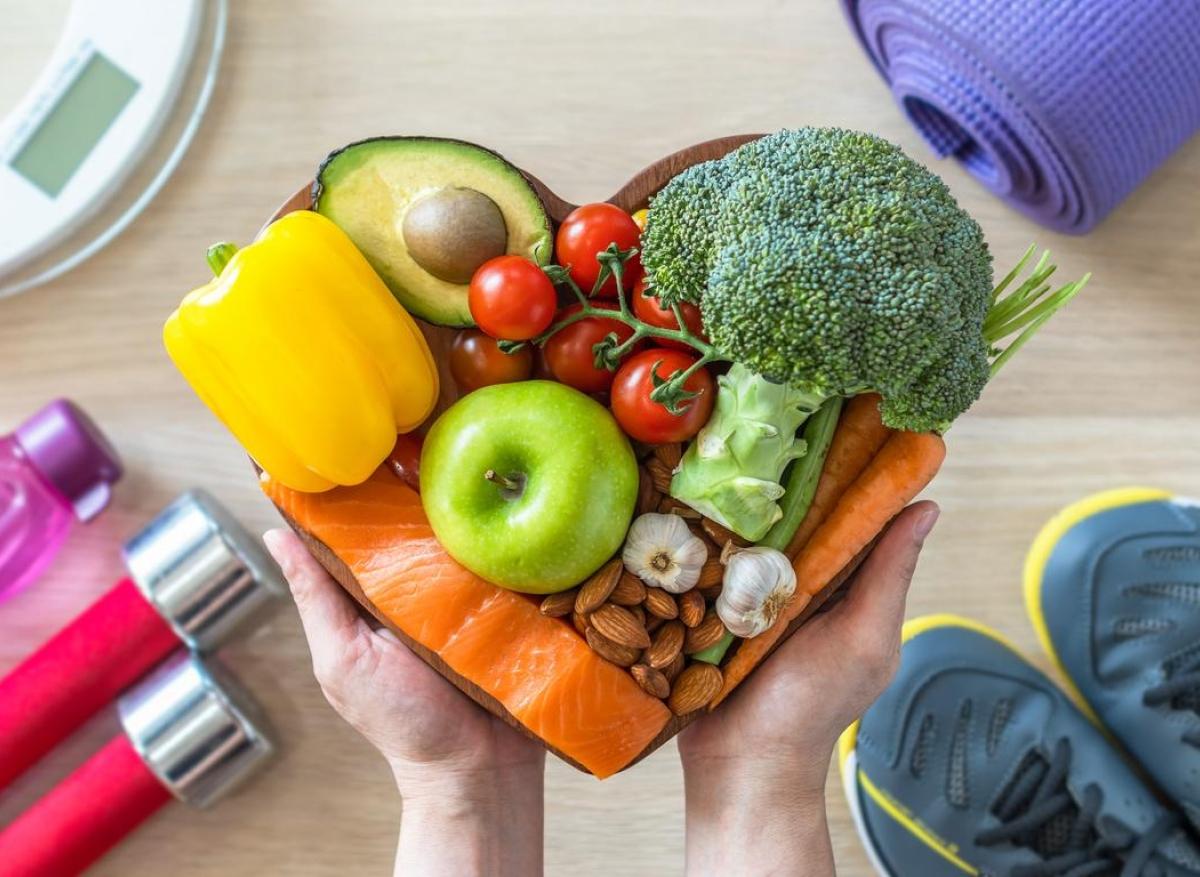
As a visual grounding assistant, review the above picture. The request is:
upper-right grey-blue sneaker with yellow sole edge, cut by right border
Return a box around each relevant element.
[1025,488,1200,827]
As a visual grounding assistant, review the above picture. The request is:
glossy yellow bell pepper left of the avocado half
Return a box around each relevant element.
[163,210,438,492]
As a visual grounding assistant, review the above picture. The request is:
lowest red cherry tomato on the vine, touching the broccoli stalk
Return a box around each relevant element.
[612,347,716,445]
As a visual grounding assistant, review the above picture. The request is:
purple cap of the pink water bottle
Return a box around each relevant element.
[13,400,121,521]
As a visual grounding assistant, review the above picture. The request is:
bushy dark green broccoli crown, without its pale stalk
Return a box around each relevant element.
[642,128,994,431]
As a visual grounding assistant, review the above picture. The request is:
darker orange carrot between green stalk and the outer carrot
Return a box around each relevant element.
[784,392,892,560]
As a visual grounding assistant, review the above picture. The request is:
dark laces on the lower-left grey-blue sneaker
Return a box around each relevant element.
[976,738,1178,877]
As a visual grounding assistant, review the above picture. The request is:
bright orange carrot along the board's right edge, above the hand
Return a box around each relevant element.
[709,432,946,709]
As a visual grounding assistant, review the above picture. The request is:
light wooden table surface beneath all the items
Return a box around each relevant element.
[0,0,1200,877]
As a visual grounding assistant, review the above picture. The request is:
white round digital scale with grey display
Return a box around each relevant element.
[0,0,227,296]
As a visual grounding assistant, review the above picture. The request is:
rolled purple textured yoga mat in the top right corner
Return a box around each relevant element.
[841,0,1200,234]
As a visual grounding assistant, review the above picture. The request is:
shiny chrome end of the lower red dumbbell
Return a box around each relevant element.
[116,650,275,807]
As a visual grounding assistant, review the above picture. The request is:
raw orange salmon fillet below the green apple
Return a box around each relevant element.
[262,468,671,779]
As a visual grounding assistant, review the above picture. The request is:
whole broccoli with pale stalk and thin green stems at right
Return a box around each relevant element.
[642,128,1087,543]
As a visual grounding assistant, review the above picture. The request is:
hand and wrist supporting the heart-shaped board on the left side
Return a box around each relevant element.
[263,529,546,875]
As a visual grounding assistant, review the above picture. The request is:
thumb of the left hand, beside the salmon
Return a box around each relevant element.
[263,529,364,679]
